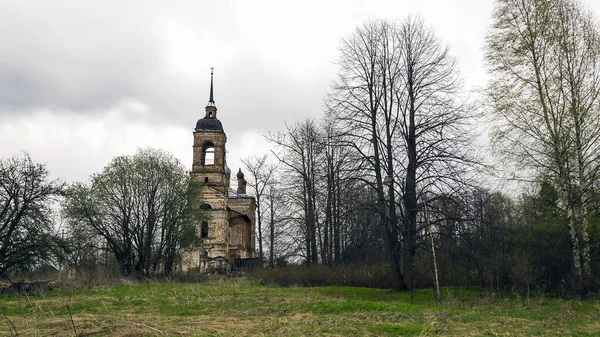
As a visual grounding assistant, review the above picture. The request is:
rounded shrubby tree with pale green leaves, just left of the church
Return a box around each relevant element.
[63,149,202,275]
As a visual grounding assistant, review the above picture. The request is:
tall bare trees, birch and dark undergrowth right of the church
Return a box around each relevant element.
[246,0,600,294]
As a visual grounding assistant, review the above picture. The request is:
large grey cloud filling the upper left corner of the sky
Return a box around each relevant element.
[0,1,161,112]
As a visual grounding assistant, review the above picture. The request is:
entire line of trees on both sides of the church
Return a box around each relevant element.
[0,0,600,296]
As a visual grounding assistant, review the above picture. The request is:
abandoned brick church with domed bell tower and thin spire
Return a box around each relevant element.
[182,71,256,273]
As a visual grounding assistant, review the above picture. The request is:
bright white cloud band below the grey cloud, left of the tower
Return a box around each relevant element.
[0,102,192,182]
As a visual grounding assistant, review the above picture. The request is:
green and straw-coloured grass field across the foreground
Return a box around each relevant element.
[0,280,600,336]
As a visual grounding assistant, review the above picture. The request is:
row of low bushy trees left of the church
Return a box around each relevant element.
[0,149,207,280]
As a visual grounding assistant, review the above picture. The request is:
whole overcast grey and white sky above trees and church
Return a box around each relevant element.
[0,0,600,182]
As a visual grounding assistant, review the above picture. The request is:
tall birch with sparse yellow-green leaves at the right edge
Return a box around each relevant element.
[486,0,600,294]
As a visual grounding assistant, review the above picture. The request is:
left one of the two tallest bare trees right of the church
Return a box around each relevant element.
[327,21,402,288]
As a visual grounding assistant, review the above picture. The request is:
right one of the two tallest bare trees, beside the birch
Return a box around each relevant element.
[396,17,479,287]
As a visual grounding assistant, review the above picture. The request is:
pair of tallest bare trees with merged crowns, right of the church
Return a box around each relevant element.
[327,17,477,288]
